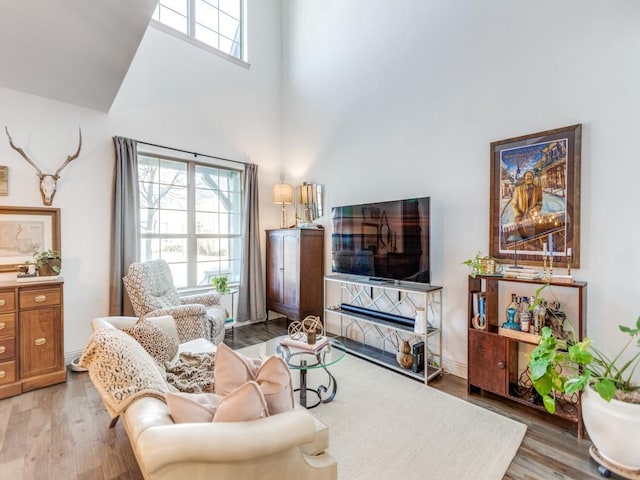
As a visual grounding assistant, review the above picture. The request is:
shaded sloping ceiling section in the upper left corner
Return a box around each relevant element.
[0,0,157,112]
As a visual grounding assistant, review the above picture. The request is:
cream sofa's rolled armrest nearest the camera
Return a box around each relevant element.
[138,410,316,473]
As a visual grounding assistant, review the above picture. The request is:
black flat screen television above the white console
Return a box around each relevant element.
[331,197,431,283]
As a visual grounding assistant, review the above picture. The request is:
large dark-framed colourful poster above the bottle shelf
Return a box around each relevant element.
[489,124,582,268]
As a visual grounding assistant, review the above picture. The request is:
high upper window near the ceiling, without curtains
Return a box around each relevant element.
[152,0,246,60]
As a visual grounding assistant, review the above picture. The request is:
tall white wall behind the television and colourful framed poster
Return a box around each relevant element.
[283,0,640,375]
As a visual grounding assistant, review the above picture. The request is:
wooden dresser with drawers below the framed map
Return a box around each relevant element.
[0,281,67,398]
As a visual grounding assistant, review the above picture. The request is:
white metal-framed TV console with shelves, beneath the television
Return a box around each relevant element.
[324,275,443,384]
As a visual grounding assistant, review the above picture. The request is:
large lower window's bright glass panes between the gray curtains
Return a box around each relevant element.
[138,153,242,288]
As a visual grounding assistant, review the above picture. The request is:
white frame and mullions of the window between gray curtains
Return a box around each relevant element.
[138,144,245,294]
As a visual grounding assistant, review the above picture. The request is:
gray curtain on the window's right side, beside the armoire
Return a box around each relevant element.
[237,164,267,322]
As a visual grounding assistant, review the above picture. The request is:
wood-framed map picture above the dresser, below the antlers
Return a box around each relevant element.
[0,207,61,272]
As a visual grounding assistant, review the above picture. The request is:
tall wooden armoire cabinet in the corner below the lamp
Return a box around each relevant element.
[266,228,324,320]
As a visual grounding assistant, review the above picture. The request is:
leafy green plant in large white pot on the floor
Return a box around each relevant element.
[528,317,640,479]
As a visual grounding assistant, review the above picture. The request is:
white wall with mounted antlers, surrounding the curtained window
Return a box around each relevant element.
[0,0,282,358]
